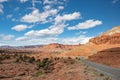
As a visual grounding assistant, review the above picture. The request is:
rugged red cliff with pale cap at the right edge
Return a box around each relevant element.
[89,26,120,45]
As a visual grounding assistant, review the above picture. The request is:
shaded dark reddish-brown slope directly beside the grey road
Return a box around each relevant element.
[88,47,120,68]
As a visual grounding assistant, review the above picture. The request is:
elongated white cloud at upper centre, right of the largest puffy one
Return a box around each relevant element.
[55,12,81,22]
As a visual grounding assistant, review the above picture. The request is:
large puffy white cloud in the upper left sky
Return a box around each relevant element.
[21,9,58,23]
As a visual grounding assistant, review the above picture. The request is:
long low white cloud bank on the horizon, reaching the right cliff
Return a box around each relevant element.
[16,35,92,45]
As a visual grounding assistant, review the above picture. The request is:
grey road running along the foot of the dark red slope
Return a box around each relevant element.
[82,59,120,80]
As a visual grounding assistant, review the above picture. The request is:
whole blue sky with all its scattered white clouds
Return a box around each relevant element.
[0,0,120,46]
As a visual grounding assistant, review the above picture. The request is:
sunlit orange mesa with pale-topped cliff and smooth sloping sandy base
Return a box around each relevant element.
[61,26,120,58]
